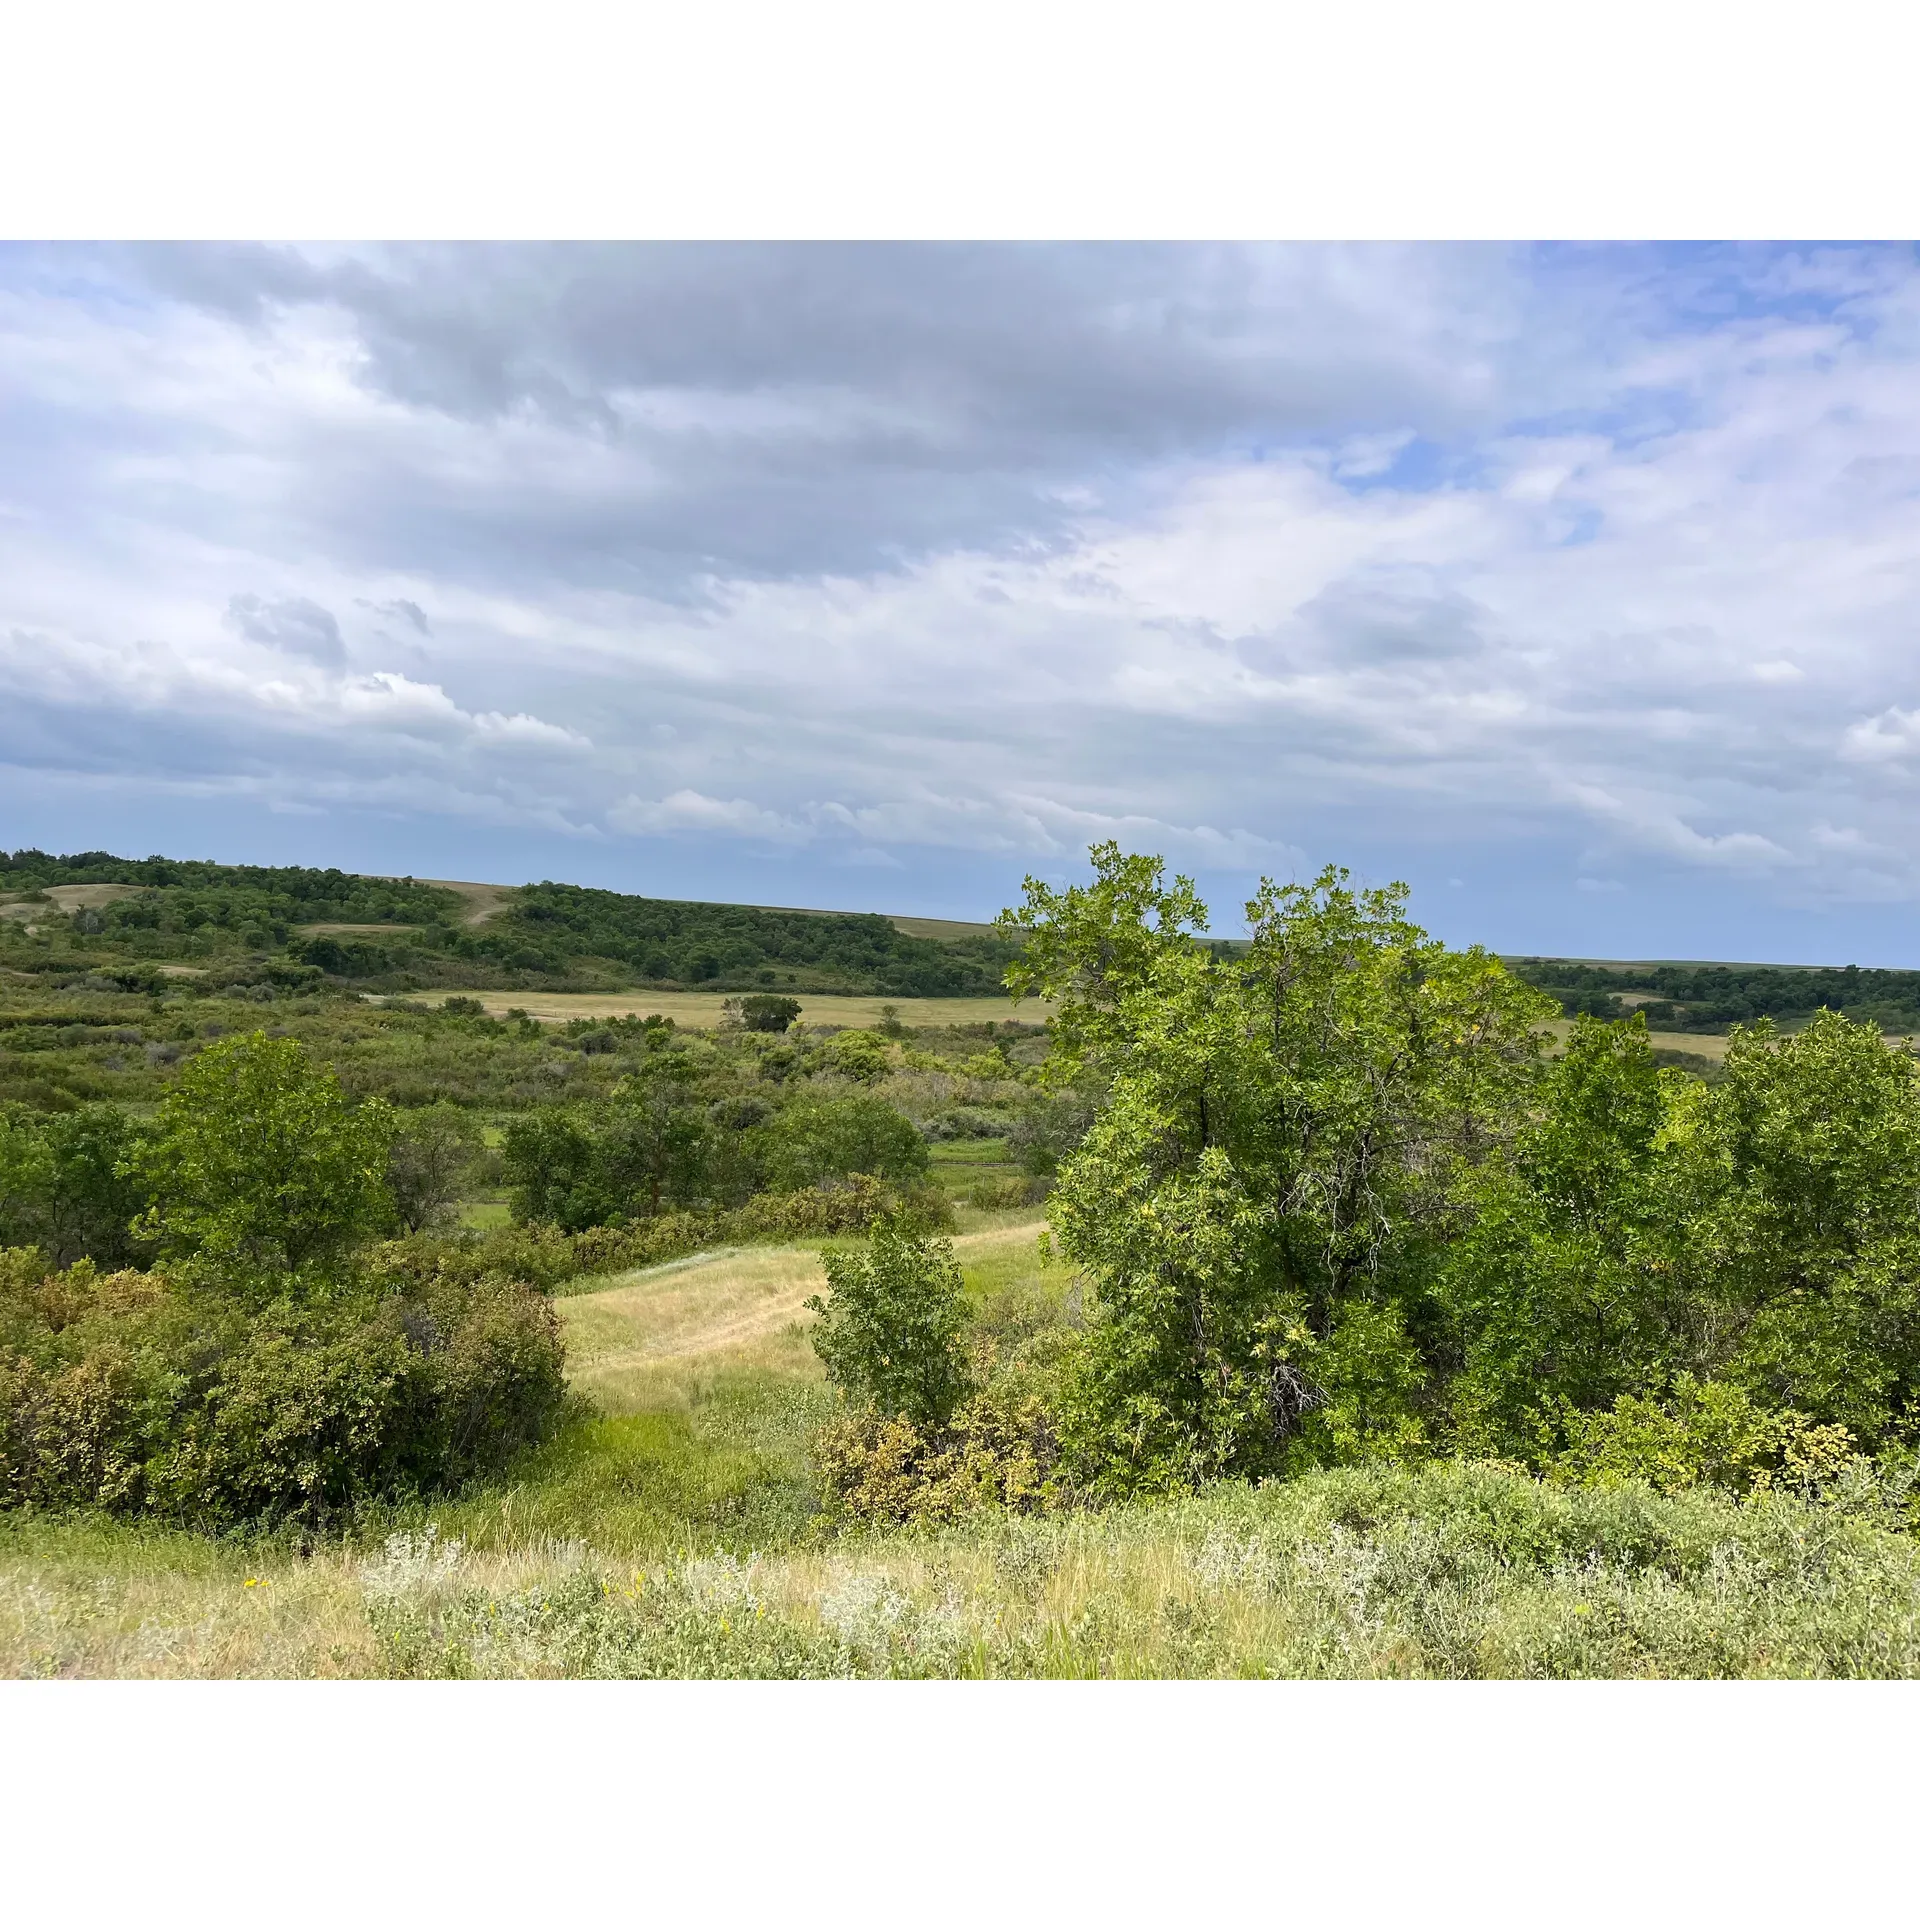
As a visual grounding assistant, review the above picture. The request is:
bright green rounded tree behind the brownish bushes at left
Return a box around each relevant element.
[129,1033,392,1286]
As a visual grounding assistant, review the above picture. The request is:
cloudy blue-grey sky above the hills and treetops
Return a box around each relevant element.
[0,244,1920,966]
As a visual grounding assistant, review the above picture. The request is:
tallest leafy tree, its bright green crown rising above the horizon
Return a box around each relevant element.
[1002,843,1555,1486]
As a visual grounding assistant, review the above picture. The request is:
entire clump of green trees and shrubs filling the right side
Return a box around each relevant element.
[956,847,1920,1492]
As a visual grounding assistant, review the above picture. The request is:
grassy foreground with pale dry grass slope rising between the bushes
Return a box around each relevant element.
[0,1215,1920,1678]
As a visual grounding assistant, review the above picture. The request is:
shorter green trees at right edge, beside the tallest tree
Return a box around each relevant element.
[1446,1012,1920,1459]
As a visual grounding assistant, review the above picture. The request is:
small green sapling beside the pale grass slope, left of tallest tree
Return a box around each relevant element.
[806,1219,970,1427]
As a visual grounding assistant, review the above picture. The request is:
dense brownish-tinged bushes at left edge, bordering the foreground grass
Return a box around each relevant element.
[0,1248,564,1526]
